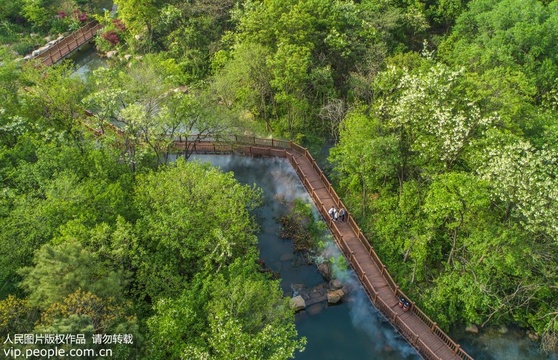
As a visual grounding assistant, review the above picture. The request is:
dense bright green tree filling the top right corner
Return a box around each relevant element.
[440,0,558,96]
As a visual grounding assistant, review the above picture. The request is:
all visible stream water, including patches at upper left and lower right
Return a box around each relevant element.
[73,47,558,360]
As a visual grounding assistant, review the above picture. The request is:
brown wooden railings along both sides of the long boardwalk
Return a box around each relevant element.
[186,135,473,360]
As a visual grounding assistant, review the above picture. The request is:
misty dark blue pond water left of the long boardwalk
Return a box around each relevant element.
[193,155,420,360]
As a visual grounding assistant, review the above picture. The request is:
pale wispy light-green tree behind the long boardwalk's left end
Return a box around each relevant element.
[83,60,236,171]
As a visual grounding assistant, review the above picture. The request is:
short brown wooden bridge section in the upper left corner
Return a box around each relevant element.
[26,21,103,66]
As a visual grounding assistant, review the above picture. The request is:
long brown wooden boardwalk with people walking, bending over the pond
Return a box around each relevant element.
[175,136,473,360]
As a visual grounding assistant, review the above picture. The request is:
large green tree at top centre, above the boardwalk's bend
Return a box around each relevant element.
[214,0,388,140]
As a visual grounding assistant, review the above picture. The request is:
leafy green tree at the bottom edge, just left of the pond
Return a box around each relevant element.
[148,259,305,359]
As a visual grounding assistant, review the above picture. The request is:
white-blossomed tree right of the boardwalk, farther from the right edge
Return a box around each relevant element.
[381,64,497,173]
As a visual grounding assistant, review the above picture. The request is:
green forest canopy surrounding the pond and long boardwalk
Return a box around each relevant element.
[0,0,558,359]
